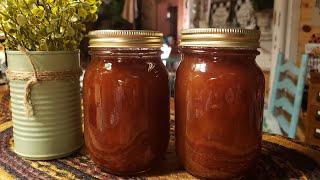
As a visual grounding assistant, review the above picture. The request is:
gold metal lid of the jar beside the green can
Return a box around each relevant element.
[88,30,163,48]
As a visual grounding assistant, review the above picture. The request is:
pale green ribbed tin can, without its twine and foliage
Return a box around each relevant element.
[6,51,83,160]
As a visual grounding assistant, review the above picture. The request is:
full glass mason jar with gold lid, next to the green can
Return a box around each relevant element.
[83,30,170,175]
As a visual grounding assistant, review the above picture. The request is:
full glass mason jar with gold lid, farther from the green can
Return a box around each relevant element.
[175,29,264,178]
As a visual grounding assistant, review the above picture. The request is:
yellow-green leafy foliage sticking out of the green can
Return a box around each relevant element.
[0,0,101,51]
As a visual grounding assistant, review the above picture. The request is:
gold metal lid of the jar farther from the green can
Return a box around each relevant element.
[179,28,260,48]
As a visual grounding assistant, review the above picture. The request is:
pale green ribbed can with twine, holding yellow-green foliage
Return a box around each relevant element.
[0,0,101,160]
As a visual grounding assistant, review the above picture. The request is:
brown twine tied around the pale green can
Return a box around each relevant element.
[6,47,82,117]
